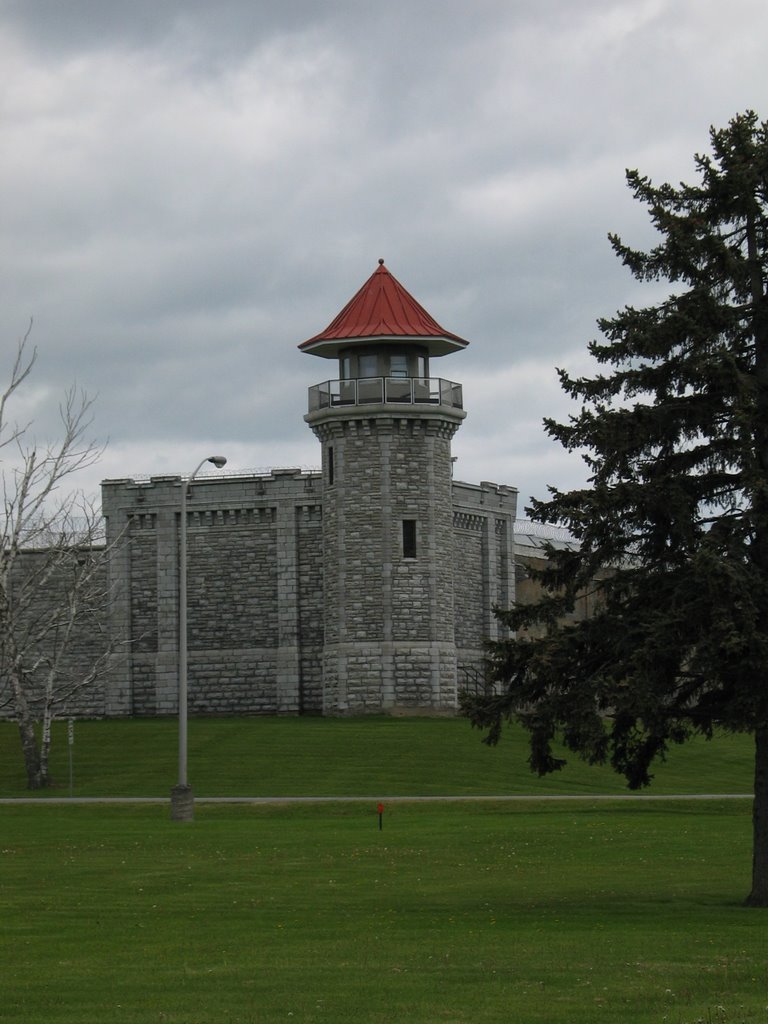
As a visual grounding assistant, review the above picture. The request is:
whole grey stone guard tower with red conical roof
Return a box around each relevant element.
[299,260,468,714]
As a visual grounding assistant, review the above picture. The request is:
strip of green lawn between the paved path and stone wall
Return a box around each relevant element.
[0,718,753,799]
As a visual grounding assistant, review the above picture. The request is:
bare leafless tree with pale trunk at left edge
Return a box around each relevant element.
[0,325,117,790]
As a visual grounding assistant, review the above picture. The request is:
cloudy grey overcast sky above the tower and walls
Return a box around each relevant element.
[0,0,768,514]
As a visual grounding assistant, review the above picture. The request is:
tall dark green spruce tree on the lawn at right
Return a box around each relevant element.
[464,112,768,906]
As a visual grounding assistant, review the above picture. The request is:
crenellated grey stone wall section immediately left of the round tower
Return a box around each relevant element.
[102,470,322,715]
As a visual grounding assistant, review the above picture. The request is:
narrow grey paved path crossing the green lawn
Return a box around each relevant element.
[0,793,753,805]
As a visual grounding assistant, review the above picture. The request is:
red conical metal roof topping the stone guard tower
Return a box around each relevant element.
[299,259,469,358]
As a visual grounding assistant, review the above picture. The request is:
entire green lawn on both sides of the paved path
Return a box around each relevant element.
[0,718,768,1024]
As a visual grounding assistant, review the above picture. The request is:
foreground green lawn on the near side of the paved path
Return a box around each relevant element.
[0,798,768,1024]
